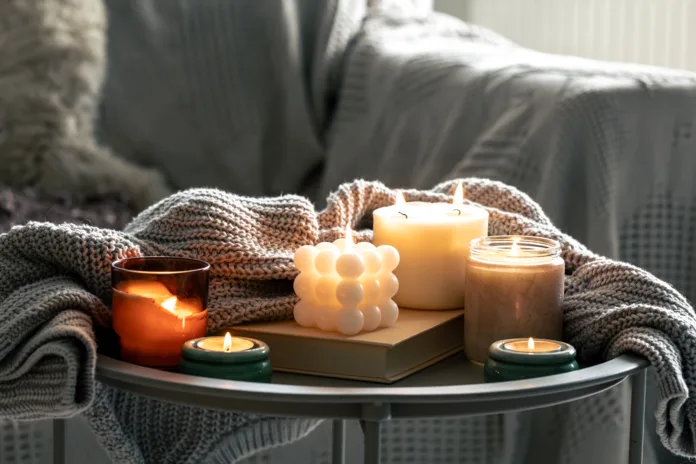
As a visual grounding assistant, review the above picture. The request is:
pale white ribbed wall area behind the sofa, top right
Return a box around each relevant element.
[435,0,696,71]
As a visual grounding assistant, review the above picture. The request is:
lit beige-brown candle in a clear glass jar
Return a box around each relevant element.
[464,236,565,364]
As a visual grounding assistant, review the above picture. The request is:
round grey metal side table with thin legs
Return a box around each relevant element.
[54,353,649,464]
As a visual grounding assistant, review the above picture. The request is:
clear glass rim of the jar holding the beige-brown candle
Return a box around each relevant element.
[470,235,561,260]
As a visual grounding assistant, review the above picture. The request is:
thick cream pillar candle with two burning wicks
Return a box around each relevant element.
[373,185,488,309]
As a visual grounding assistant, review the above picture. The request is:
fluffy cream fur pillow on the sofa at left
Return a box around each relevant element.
[0,0,169,208]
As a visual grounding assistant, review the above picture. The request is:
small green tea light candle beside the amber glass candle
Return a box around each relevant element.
[179,332,272,382]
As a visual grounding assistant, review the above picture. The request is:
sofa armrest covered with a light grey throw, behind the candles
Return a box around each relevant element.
[323,10,696,304]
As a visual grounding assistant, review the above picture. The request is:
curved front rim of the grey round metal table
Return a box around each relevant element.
[96,354,650,404]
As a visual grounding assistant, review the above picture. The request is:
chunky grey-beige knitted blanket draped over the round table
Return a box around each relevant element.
[0,179,696,463]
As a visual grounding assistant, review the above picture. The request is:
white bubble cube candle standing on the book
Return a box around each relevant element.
[293,229,399,335]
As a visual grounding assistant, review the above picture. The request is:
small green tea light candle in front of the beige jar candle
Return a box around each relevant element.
[483,338,579,382]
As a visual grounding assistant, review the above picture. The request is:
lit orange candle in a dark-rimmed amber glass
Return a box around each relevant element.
[111,256,210,368]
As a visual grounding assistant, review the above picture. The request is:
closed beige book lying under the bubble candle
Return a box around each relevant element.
[223,309,464,383]
